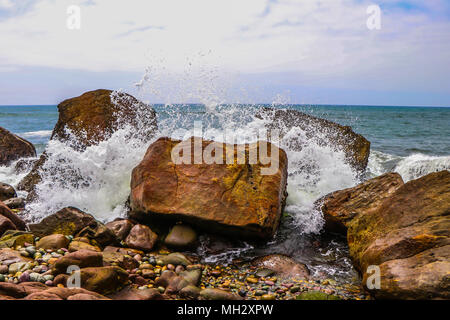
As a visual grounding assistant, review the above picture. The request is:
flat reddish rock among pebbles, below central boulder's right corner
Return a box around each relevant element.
[252,254,309,279]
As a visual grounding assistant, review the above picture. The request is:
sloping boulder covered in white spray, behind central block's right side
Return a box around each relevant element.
[256,108,370,171]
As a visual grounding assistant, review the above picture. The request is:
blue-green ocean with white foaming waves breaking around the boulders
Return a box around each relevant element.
[0,105,450,281]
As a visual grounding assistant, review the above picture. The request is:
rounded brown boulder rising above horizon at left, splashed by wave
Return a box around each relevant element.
[18,89,157,192]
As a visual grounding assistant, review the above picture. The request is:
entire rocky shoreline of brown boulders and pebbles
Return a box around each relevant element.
[0,90,450,300]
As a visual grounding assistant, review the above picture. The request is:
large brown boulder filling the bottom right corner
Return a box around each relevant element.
[347,170,450,299]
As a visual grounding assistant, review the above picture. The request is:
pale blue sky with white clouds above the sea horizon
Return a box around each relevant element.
[0,0,450,106]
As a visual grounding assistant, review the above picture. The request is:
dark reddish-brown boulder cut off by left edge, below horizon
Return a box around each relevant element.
[0,127,36,166]
